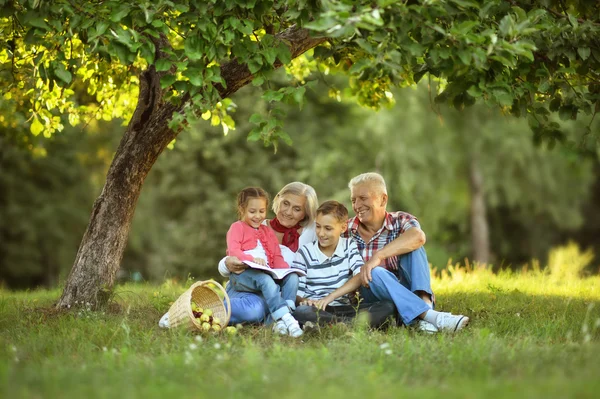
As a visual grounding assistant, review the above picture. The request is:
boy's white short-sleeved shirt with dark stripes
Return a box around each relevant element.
[292,238,364,306]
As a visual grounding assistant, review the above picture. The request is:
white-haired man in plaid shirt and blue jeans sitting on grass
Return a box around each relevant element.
[346,173,469,333]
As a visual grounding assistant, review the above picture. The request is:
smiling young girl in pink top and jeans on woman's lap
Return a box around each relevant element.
[227,187,302,337]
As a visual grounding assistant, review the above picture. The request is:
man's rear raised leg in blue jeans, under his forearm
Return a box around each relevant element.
[397,247,434,307]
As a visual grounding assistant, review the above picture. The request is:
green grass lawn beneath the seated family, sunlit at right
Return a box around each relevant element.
[0,267,600,399]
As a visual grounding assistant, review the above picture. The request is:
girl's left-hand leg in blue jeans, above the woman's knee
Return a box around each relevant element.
[229,269,290,320]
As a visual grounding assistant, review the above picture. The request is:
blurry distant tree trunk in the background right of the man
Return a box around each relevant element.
[469,155,490,264]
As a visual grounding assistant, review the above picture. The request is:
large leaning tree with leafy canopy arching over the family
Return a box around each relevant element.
[0,0,600,307]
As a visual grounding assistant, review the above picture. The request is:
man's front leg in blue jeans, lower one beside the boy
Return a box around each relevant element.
[361,267,431,325]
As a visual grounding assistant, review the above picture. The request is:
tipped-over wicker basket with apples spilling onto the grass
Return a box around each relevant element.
[169,280,231,330]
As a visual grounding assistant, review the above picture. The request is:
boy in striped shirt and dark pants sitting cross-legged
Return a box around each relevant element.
[293,201,395,327]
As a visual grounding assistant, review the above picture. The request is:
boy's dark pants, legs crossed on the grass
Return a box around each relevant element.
[293,301,396,328]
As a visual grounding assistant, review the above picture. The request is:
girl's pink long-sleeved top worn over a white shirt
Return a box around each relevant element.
[227,220,289,269]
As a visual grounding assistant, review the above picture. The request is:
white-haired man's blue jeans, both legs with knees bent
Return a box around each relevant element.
[360,247,433,325]
